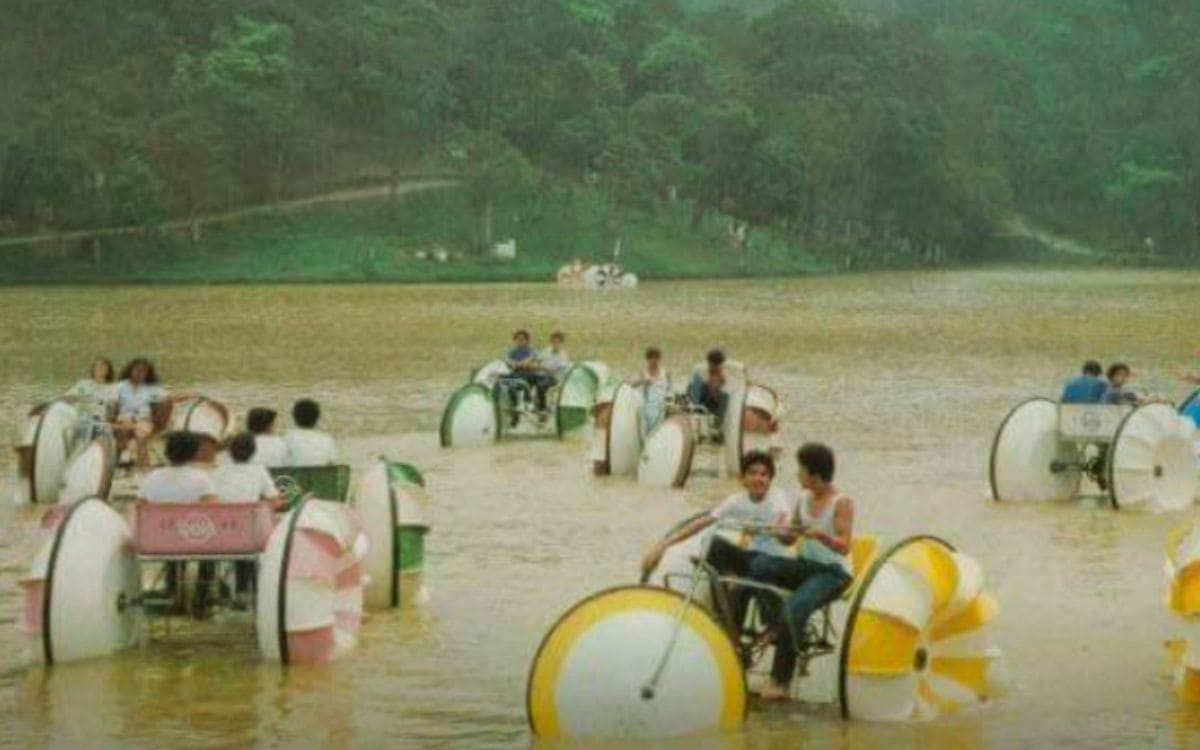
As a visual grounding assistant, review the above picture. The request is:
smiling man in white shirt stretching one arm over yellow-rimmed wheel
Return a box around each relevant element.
[642,450,796,623]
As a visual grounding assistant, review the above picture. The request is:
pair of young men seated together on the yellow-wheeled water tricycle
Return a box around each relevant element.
[642,443,854,701]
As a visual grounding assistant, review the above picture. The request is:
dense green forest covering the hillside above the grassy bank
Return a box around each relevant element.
[0,0,1200,262]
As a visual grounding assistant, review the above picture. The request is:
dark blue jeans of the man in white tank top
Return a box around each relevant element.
[750,554,851,685]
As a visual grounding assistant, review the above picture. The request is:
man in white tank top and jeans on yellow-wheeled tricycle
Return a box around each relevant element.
[750,443,854,701]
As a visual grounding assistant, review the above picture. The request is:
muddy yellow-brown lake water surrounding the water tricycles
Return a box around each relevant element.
[0,271,1200,749]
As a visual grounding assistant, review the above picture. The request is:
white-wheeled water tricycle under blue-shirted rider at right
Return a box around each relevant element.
[988,398,1196,510]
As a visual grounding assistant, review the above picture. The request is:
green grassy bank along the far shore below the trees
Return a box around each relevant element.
[0,187,833,283]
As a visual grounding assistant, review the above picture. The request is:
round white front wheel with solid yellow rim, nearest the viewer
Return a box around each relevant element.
[526,586,748,740]
